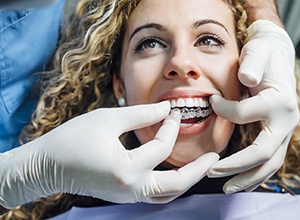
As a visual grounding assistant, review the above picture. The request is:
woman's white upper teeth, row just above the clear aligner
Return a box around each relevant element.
[170,98,210,108]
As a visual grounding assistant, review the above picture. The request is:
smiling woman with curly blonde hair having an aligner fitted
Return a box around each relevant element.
[3,0,299,219]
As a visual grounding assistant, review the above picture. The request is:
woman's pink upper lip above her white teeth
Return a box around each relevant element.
[156,90,211,102]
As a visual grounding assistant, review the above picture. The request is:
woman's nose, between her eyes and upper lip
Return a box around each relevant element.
[163,48,200,80]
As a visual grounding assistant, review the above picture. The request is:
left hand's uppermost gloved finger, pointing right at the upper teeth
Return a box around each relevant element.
[110,101,171,135]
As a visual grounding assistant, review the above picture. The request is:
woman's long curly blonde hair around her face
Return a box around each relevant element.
[3,0,300,220]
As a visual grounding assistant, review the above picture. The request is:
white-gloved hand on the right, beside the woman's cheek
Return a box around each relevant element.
[208,20,299,193]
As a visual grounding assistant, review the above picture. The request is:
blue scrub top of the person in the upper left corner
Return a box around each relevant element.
[0,0,65,152]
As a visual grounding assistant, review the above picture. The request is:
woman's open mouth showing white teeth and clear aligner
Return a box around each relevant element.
[170,98,212,124]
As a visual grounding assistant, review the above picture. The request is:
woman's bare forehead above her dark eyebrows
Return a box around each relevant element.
[127,0,235,32]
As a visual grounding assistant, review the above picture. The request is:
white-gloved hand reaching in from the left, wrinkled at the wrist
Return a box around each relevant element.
[0,102,219,208]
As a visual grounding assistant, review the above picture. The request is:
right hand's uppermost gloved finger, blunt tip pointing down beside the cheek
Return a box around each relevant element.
[238,39,270,87]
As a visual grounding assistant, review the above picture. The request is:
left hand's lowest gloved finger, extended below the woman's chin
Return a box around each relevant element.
[150,152,219,198]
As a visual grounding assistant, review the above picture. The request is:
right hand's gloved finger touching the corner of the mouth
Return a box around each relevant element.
[209,89,276,124]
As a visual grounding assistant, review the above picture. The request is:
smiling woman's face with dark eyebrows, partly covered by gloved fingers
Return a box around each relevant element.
[114,0,241,166]
